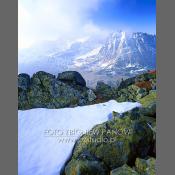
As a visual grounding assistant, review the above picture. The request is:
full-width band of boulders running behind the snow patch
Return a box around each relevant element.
[18,71,156,110]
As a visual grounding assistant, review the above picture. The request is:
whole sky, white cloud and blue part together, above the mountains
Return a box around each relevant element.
[18,0,156,48]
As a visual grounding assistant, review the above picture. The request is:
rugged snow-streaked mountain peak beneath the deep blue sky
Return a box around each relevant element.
[74,32,156,73]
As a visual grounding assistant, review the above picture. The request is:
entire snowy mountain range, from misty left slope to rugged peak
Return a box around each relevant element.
[18,31,156,84]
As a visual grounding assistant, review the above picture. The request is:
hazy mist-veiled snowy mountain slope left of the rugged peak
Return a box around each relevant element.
[18,37,104,75]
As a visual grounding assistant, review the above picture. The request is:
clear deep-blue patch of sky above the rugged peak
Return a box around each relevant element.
[91,0,156,33]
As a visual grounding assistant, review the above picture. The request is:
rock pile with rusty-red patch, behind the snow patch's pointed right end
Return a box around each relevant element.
[95,71,156,102]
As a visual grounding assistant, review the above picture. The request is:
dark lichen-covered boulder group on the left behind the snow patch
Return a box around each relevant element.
[18,71,88,110]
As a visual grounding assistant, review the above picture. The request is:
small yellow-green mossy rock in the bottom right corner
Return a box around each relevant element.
[135,158,156,175]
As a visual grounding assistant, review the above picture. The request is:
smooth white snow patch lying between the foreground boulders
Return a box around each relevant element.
[18,100,140,175]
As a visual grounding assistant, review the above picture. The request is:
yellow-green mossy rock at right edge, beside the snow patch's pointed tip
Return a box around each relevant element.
[139,91,157,107]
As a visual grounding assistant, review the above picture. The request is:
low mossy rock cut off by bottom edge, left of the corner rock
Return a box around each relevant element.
[110,164,139,175]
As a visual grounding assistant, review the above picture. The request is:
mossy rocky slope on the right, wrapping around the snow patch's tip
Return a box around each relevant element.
[62,71,156,175]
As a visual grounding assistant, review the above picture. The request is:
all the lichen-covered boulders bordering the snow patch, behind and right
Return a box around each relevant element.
[18,71,156,175]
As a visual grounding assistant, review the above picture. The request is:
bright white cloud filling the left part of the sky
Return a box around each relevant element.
[18,0,107,48]
